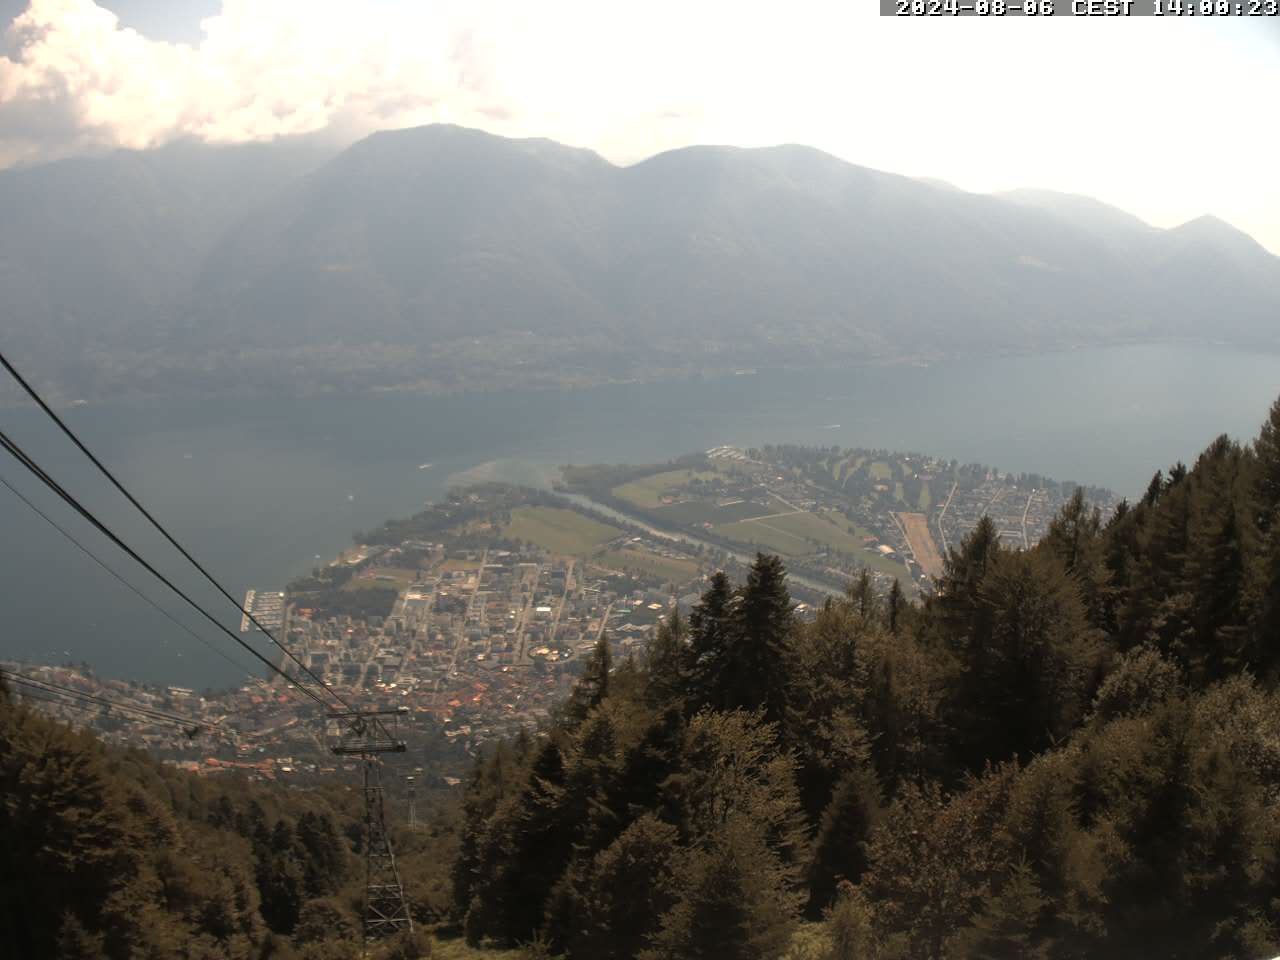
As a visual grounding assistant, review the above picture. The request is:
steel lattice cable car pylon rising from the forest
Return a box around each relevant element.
[329,708,413,947]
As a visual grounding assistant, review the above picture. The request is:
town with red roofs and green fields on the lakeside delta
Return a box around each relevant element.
[0,447,1114,787]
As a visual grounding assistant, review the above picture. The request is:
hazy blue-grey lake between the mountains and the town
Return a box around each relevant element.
[0,344,1280,689]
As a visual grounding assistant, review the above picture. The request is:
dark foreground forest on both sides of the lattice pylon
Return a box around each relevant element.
[0,402,1280,960]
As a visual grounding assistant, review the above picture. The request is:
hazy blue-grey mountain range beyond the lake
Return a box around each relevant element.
[0,125,1280,399]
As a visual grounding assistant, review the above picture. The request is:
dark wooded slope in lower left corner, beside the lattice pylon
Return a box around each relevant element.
[0,689,447,960]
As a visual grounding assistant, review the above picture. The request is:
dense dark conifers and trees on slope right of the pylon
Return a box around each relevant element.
[453,391,1280,960]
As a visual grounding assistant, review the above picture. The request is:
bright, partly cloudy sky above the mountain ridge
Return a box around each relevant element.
[0,0,1280,255]
